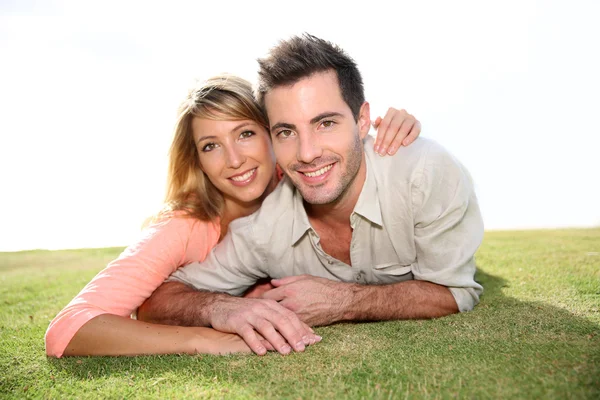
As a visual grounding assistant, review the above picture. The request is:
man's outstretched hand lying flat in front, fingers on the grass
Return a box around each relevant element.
[210,296,321,355]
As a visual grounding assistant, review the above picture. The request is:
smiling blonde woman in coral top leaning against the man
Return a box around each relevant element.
[46,75,420,357]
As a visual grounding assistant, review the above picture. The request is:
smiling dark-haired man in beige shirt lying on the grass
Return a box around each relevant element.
[141,35,483,354]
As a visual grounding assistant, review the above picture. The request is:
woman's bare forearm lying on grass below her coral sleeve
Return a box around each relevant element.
[63,314,250,356]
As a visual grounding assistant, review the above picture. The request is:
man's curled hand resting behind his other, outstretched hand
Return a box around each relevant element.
[263,275,353,326]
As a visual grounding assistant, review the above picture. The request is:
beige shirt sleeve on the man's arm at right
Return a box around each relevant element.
[412,144,483,312]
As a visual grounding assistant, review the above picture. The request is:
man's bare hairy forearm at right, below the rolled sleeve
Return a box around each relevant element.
[344,281,458,321]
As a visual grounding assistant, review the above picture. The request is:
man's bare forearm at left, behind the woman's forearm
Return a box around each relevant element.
[137,282,229,326]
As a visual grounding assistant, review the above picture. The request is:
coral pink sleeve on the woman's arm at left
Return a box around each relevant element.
[45,217,219,357]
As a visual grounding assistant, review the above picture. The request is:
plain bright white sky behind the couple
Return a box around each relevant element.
[0,0,600,251]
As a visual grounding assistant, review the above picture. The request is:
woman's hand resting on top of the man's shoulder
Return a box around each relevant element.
[372,108,421,156]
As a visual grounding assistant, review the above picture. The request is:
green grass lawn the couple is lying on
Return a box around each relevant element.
[0,229,600,399]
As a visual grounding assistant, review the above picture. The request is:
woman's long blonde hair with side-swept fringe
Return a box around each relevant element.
[159,74,268,221]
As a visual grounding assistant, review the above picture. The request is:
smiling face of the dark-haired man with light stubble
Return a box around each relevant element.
[265,70,370,204]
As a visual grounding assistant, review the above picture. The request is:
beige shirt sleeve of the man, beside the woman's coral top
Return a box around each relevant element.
[169,219,269,296]
